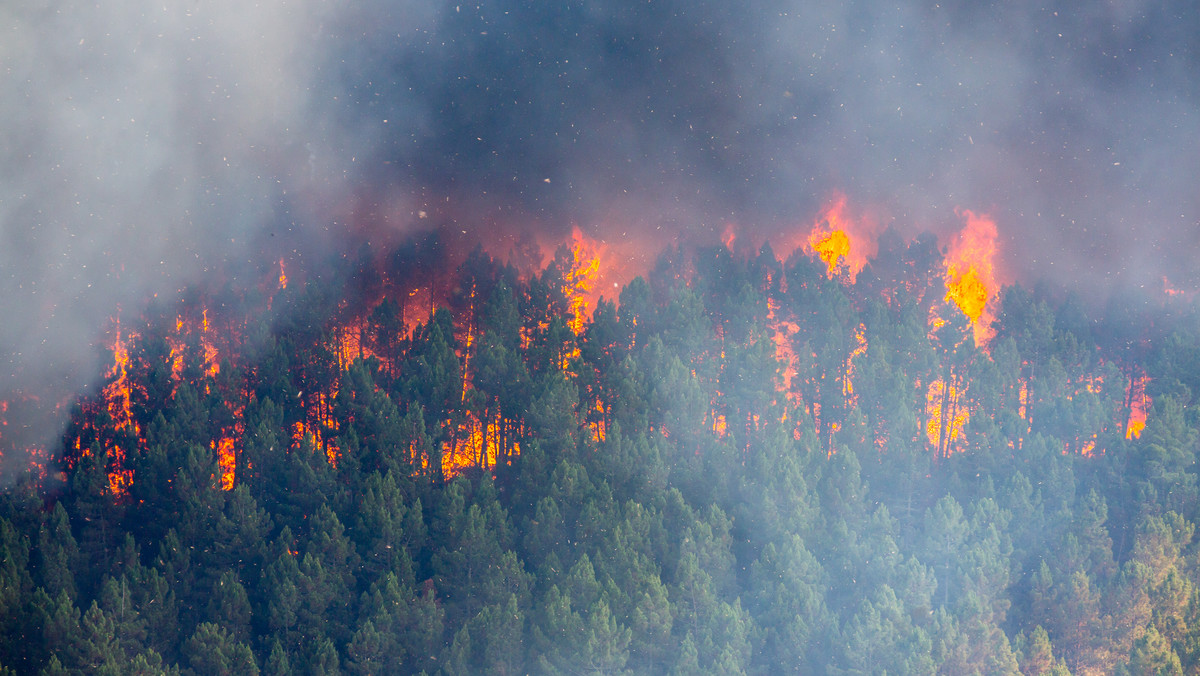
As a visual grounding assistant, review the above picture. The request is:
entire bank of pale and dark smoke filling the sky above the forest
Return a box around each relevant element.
[0,0,1200,475]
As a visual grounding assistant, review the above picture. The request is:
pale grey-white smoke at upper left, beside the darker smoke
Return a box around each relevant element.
[0,0,350,465]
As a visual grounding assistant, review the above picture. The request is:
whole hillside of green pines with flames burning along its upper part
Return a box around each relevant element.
[0,232,1200,675]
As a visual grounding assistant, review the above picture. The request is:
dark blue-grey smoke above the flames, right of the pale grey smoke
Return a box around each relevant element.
[326,0,1200,288]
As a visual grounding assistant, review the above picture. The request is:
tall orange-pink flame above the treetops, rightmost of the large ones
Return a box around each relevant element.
[946,210,997,346]
